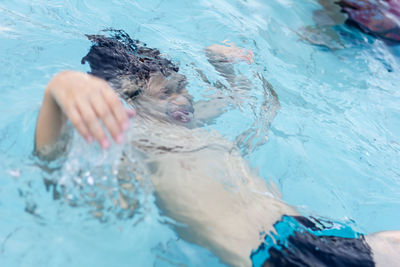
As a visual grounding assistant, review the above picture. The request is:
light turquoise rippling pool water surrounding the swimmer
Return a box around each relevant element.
[0,0,400,266]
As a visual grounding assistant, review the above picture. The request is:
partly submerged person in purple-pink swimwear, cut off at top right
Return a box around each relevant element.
[298,0,400,50]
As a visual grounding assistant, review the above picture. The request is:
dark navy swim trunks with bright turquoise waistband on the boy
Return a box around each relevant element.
[250,216,375,267]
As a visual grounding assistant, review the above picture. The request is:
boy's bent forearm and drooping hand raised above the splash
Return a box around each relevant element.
[35,71,134,159]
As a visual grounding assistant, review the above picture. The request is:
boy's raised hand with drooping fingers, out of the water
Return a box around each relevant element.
[43,71,135,148]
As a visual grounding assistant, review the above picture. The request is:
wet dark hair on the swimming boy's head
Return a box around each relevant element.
[81,29,181,98]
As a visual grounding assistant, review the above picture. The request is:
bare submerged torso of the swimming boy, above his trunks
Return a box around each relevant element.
[133,116,297,266]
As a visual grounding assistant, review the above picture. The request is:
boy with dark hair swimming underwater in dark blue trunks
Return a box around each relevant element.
[35,32,400,266]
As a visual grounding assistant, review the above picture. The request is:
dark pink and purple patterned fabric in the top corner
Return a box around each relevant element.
[338,0,400,42]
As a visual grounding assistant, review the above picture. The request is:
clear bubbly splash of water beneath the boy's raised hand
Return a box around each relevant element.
[49,124,151,224]
